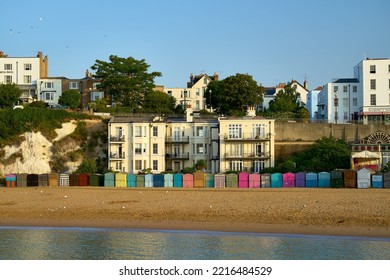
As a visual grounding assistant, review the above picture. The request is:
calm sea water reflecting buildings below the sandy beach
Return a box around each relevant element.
[0,227,390,260]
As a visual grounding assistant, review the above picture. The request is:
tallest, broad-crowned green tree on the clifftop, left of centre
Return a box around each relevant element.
[91,55,161,110]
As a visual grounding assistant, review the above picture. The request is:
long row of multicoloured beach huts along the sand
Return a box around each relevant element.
[6,168,390,189]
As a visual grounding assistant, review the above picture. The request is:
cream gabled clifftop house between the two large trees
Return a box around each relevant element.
[163,73,218,111]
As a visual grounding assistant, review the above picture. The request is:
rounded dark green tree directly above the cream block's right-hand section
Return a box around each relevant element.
[205,73,265,115]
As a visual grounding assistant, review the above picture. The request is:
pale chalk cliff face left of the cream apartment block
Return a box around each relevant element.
[0,120,106,176]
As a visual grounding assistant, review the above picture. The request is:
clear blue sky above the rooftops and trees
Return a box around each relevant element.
[0,0,390,89]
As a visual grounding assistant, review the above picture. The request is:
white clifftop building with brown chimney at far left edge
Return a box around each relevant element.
[0,52,48,102]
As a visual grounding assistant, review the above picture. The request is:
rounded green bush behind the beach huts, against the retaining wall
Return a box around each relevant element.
[294,137,351,172]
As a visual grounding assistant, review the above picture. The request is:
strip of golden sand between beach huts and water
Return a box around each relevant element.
[0,187,390,237]
